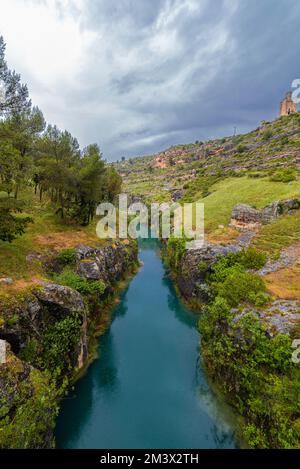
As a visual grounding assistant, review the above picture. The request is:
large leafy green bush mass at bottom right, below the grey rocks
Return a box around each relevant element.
[199,308,300,448]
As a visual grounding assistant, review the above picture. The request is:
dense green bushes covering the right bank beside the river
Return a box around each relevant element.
[199,249,300,448]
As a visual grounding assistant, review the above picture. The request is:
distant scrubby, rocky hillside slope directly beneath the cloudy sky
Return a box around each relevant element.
[114,113,300,205]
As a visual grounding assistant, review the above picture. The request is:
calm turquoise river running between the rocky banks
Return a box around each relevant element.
[56,241,237,449]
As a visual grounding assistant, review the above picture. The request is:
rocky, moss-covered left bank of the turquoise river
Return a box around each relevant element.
[0,240,137,448]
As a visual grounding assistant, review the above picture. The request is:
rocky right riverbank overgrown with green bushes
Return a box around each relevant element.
[164,240,300,448]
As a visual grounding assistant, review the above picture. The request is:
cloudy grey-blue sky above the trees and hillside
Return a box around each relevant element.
[0,0,300,160]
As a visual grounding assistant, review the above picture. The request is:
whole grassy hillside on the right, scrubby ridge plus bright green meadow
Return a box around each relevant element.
[115,113,300,306]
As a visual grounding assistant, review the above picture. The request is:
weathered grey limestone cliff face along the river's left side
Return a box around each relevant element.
[0,242,137,448]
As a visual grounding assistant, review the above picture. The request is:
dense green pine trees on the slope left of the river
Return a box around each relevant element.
[0,37,121,242]
